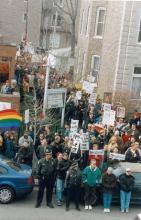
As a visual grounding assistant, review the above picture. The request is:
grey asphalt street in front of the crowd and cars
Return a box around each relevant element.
[0,189,141,220]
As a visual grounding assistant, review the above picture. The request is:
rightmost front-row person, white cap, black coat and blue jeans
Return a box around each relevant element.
[119,168,135,213]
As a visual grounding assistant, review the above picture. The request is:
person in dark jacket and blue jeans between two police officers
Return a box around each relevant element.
[56,153,70,206]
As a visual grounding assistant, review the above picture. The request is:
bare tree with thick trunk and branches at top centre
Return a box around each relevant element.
[54,0,79,58]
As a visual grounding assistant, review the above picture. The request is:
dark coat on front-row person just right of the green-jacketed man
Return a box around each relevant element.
[102,173,117,193]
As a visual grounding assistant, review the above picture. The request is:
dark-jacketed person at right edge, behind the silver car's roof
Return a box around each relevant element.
[125,142,141,163]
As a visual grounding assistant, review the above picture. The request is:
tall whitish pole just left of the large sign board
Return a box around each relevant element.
[43,65,50,115]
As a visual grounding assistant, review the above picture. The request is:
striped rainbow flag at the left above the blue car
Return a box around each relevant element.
[0,109,22,130]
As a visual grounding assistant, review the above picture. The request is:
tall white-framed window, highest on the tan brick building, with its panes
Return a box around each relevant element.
[95,7,106,38]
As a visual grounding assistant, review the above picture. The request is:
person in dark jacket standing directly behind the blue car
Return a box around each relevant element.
[17,142,33,167]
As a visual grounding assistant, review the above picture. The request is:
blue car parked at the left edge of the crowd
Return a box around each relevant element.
[0,156,34,204]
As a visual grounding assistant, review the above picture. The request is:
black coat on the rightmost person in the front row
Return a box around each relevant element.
[119,173,135,192]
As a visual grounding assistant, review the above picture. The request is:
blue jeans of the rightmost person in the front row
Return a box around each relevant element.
[120,190,131,210]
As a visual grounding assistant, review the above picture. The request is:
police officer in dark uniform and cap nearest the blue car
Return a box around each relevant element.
[35,149,56,208]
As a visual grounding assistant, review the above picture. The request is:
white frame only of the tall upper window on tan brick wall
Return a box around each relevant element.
[94,7,106,39]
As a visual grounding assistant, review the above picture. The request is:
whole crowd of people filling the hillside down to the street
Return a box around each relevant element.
[0,50,141,213]
